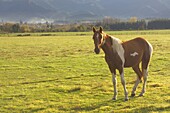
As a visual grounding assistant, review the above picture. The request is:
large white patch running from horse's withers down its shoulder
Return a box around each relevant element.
[111,37,125,67]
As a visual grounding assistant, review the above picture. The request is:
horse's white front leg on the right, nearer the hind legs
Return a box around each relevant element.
[119,69,129,101]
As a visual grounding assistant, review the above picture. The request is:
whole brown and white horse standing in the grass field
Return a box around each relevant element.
[93,27,153,101]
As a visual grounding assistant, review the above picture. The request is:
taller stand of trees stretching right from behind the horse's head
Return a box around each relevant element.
[96,17,170,30]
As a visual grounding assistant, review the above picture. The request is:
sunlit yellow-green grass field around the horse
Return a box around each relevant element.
[0,30,170,113]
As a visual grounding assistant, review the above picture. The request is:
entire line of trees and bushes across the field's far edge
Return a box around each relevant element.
[0,17,170,33]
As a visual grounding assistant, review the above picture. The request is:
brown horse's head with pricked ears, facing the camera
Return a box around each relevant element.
[93,27,105,54]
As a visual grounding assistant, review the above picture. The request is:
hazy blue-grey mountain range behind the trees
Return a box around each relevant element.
[0,0,170,21]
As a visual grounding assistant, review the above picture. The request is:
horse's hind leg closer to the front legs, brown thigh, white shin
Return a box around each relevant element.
[131,64,142,97]
